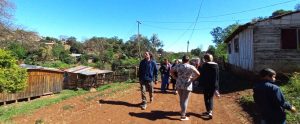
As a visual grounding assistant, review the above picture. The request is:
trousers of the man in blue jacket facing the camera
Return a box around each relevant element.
[140,81,153,105]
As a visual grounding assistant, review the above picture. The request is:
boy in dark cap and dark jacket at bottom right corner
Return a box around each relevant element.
[253,68,296,124]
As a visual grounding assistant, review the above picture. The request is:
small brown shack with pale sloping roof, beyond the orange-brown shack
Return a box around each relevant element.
[64,66,113,89]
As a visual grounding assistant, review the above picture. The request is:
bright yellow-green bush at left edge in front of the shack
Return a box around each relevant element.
[0,49,28,93]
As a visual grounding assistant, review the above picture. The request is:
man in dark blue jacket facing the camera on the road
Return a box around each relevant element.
[139,52,157,110]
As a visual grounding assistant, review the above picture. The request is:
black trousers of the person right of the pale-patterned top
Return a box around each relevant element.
[203,88,215,112]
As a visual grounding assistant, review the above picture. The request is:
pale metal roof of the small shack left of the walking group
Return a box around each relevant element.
[65,66,113,75]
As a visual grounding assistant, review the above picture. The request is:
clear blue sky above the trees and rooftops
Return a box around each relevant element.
[12,0,300,52]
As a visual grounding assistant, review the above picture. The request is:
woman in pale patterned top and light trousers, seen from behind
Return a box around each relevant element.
[171,56,200,121]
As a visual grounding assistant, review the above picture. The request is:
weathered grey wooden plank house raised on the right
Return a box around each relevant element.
[225,11,300,73]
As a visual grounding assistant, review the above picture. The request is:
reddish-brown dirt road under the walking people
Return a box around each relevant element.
[13,84,252,124]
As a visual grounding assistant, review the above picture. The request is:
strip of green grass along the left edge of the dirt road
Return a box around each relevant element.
[0,83,133,123]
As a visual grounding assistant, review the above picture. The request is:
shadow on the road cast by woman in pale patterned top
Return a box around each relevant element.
[129,111,179,121]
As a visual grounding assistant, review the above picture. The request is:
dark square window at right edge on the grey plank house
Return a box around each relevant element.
[281,29,300,49]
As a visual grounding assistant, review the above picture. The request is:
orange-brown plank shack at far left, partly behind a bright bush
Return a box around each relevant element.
[0,64,64,104]
